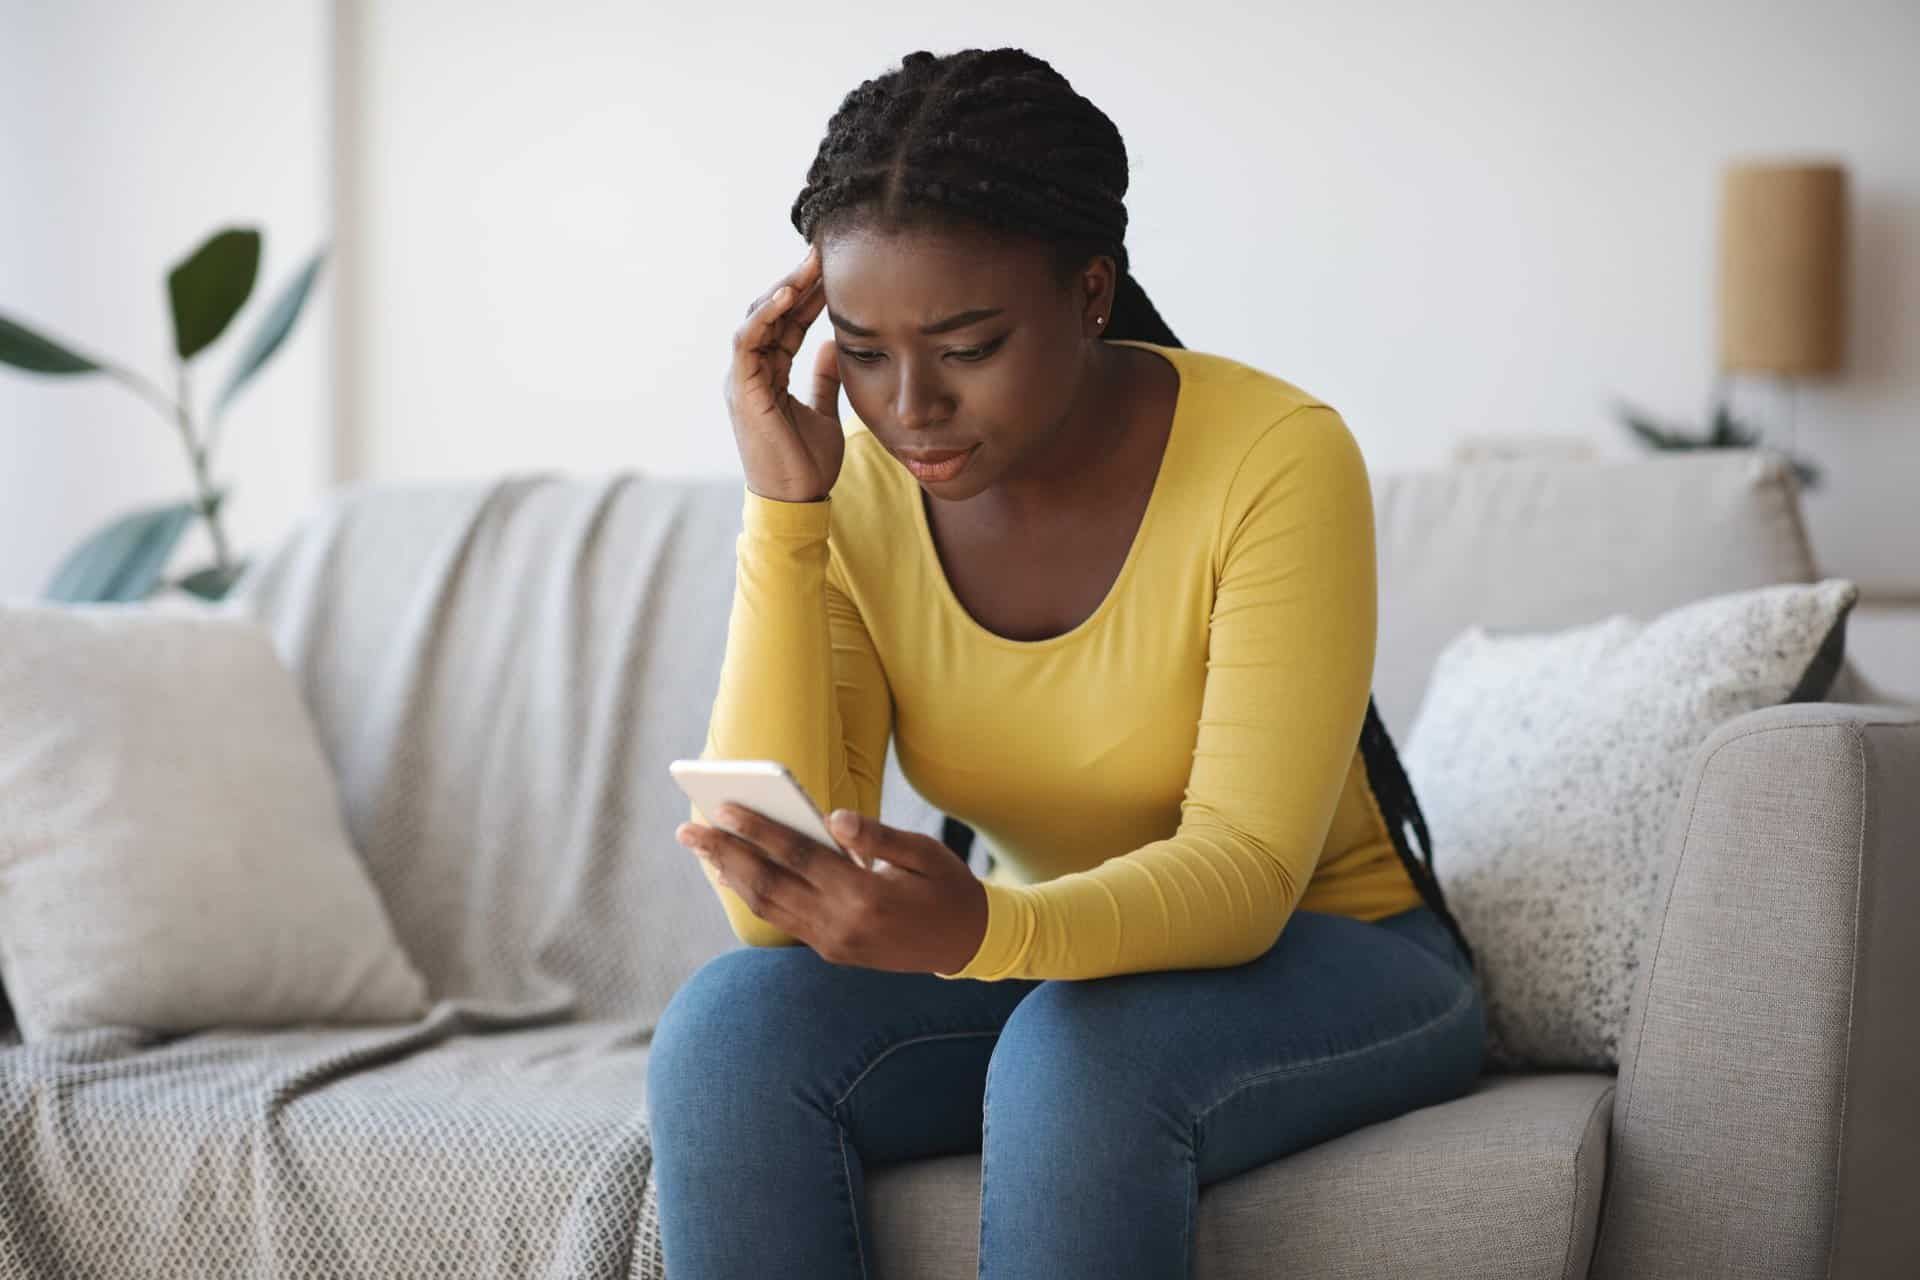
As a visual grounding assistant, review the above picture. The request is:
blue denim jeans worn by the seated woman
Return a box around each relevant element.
[647,906,1486,1280]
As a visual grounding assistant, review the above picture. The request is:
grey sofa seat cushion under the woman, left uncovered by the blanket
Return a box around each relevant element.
[866,1073,1613,1280]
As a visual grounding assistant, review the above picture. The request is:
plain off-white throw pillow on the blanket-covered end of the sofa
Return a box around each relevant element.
[0,603,426,1040]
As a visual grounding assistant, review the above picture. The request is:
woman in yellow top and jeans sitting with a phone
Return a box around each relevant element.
[649,48,1484,1280]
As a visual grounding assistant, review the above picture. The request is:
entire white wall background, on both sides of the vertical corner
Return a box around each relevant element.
[11,0,1920,595]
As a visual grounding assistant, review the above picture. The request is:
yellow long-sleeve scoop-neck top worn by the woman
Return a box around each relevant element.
[693,340,1421,981]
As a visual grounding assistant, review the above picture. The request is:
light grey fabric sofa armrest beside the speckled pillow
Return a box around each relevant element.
[1592,702,1920,1280]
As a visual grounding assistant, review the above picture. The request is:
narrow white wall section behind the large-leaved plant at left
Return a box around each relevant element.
[0,0,330,597]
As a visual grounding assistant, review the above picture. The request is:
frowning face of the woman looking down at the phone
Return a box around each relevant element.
[820,220,1114,501]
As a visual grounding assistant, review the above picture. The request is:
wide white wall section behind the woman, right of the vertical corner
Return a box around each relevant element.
[342,0,1920,585]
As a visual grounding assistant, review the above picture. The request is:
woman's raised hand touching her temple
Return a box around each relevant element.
[726,246,847,503]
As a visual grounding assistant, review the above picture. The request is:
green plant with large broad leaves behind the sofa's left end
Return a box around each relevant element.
[0,226,326,603]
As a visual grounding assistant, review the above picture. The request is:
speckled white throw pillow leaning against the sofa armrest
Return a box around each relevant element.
[1405,578,1859,1069]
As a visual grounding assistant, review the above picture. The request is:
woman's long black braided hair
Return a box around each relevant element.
[791,48,1475,965]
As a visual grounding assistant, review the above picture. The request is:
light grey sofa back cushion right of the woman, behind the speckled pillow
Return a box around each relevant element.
[1373,449,1816,741]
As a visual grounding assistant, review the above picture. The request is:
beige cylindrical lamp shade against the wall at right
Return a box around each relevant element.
[1718,163,1847,374]
